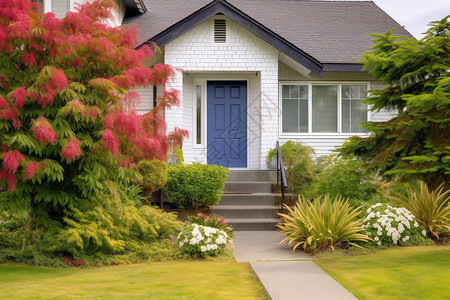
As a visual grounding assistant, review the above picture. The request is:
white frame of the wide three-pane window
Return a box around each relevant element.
[278,81,370,138]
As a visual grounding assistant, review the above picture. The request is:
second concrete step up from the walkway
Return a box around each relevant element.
[211,205,280,219]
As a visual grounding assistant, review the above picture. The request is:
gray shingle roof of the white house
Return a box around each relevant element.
[124,0,411,63]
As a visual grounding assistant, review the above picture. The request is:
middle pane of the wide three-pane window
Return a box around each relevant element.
[312,86,337,132]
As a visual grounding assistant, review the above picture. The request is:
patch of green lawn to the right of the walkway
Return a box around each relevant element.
[315,245,450,300]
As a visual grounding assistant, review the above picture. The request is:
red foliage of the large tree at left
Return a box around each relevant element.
[0,0,187,190]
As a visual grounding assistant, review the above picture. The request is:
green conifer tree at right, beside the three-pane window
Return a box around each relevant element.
[340,16,450,189]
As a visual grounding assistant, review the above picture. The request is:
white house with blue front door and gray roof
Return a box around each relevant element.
[44,0,411,169]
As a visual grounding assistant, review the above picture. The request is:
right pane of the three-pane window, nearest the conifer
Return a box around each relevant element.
[342,85,367,133]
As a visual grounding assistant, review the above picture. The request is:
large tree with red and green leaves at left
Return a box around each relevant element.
[0,0,187,232]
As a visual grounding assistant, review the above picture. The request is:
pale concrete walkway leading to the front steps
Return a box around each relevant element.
[233,231,356,300]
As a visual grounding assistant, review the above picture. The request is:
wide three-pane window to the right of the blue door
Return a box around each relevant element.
[281,84,367,133]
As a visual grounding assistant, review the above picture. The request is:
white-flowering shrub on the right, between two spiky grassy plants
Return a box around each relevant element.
[362,203,426,246]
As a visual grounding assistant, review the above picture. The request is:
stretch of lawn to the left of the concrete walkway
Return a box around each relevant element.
[0,261,266,300]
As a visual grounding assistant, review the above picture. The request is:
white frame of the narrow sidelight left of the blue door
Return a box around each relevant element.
[192,79,206,149]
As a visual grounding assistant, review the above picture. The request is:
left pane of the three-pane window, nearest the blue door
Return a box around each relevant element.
[282,85,308,132]
